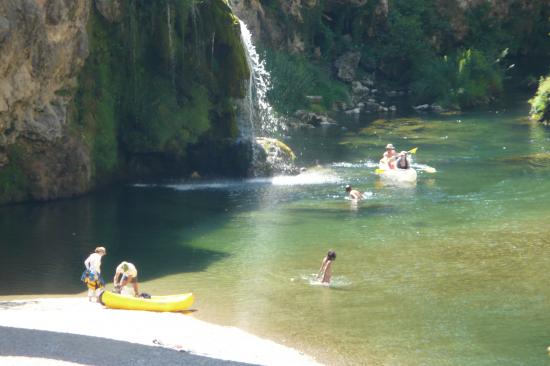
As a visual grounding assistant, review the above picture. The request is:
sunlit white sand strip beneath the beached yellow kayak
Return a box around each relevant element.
[0,298,319,366]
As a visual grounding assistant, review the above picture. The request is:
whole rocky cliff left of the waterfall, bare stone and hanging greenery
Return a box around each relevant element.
[0,0,249,202]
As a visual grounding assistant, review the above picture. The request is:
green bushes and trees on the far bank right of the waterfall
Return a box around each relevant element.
[262,0,550,112]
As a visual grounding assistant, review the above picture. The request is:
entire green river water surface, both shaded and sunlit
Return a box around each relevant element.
[0,110,550,365]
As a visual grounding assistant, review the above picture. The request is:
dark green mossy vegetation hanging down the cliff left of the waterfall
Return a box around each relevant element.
[73,0,249,182]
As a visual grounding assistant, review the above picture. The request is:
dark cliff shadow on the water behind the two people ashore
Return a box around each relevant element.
[0,187,240,296]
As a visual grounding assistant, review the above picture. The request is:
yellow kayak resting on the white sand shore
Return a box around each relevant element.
[99,291,195,311]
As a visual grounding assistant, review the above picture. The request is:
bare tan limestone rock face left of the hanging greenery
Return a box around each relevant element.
[0,0,90,200]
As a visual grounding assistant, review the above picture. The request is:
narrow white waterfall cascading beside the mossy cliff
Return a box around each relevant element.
[239,20,282,138]
